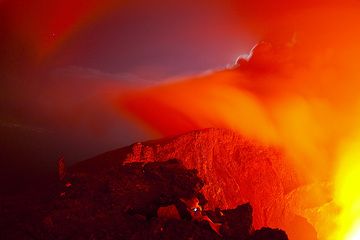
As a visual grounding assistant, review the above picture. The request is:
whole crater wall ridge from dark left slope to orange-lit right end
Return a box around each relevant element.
[71,129,320,240]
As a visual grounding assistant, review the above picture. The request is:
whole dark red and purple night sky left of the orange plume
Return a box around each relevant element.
[0,0,258,191]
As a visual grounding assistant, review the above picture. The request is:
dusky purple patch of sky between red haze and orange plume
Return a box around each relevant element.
[54,1,256,80]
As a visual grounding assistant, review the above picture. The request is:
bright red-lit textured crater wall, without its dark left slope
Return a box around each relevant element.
[125,129,300,231]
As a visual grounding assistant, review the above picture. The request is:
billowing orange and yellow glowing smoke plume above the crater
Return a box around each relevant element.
[116,3,360,240]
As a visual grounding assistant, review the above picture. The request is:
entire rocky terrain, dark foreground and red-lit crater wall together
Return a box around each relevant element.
[0,129,316,240]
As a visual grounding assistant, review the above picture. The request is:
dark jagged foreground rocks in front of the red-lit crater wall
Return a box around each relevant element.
[1,159,287,240]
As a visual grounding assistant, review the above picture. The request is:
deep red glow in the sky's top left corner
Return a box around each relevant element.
[0,0,123,59]
